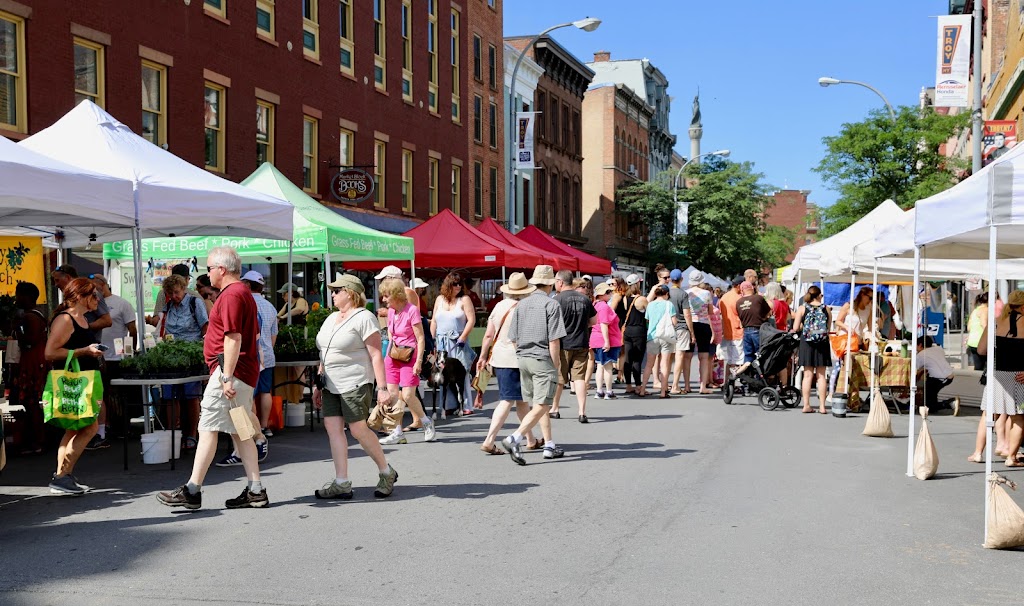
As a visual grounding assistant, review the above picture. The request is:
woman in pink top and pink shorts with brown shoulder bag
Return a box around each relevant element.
[380,278,435,444]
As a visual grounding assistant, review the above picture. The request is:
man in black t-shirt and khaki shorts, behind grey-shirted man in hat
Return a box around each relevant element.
[551,269,601,421]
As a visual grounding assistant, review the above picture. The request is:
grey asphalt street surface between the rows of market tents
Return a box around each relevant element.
[0,380,1024,605]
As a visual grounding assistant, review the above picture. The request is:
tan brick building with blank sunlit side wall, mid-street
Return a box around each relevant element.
[583,83,652,269]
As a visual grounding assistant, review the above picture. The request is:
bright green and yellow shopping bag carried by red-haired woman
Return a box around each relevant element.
[43,351,103,431]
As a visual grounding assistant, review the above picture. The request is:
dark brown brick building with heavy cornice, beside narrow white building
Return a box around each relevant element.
[505,36,594,246]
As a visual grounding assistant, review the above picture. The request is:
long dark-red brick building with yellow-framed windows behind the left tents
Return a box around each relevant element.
[0,0,468,236]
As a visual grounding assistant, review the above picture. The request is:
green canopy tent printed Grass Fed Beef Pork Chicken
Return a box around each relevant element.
[103,163,415,313]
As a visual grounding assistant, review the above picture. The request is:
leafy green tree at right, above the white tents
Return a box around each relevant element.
[813,106,970,236]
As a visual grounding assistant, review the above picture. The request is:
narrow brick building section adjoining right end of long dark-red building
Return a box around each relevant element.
[464,0,506,224]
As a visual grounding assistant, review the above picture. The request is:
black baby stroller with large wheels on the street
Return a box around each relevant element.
[722,322,800,410]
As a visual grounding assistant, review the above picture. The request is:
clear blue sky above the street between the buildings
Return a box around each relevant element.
[505,0,948,206]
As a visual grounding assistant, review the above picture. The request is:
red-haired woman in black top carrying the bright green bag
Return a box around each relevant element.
[46,277,103,494]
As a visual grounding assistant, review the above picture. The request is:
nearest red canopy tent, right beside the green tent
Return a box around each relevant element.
[345,209,547,269]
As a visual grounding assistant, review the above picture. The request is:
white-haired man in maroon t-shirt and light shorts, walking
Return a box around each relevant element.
[157,247,270,509]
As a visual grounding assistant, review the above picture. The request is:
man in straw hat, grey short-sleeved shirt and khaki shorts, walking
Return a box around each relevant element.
[502,265,565,465]
